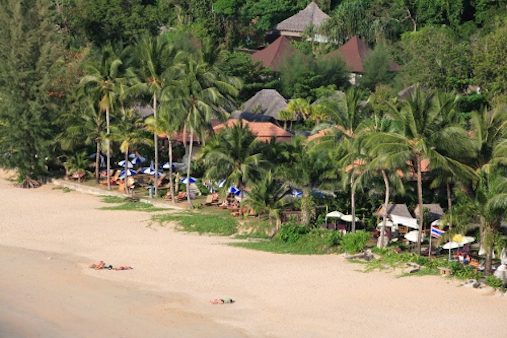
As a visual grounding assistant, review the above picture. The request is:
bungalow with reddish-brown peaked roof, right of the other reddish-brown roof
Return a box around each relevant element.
[324,36,400,85]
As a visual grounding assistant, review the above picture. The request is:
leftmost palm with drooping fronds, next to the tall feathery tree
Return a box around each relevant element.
[59,97,106,183]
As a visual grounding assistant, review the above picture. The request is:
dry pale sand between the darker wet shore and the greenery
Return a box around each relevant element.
[0,170,507,337]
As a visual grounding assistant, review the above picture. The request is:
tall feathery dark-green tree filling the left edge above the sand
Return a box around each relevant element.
[0,0,66,180]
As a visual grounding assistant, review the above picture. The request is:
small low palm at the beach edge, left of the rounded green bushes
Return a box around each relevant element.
[245,170,289,232]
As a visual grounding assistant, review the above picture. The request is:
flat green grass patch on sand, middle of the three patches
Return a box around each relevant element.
[152,213,238,236]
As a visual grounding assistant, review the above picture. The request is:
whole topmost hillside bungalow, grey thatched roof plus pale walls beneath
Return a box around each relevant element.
[274,1,329,42]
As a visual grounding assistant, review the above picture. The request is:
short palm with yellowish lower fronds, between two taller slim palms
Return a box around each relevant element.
[112,109,151,193]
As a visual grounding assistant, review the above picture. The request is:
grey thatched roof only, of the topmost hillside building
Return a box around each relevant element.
[275,1,329,33]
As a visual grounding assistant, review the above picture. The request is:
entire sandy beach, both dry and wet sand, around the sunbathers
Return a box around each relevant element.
[0,173,507,338]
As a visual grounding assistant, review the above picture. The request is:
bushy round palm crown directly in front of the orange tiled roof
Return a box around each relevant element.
[202,120,265,197]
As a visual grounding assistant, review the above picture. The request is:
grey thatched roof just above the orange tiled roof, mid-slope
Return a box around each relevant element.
[242,89,287,120]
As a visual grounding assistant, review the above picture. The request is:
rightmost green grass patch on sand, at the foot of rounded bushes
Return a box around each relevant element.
[232,229,339,255]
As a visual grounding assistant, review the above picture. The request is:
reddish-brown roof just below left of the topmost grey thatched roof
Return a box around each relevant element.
[252,36,298,70]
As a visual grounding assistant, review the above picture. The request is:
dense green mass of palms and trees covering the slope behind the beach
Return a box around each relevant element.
[0,0,507,276]
